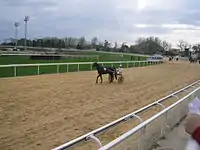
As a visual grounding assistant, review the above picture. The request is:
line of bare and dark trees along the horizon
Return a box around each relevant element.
[2,37,200,56]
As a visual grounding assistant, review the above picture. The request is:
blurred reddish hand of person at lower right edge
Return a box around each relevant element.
[185,114,200,135]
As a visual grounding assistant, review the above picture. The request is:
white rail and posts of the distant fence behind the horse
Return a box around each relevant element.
[0,60,163,77]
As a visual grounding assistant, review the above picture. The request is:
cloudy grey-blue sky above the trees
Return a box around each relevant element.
[0,0,200,46]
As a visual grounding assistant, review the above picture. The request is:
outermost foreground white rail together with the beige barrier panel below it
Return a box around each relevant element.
[99,84,200,150]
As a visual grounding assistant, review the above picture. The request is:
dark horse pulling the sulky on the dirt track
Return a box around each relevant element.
[92,62,117,83]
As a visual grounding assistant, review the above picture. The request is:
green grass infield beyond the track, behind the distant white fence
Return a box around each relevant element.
[0,52,150,77]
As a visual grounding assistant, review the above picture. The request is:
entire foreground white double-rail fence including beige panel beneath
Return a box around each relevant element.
[53,80,200,150]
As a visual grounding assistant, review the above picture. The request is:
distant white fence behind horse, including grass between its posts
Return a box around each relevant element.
[0,60,162,77]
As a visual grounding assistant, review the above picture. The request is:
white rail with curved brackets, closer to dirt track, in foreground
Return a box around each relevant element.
[53,80,200,150]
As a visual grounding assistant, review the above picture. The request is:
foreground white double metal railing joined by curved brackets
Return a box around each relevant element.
[53,80,200,150]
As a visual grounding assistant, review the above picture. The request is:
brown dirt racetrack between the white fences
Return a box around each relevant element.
[0,61,200,150]
